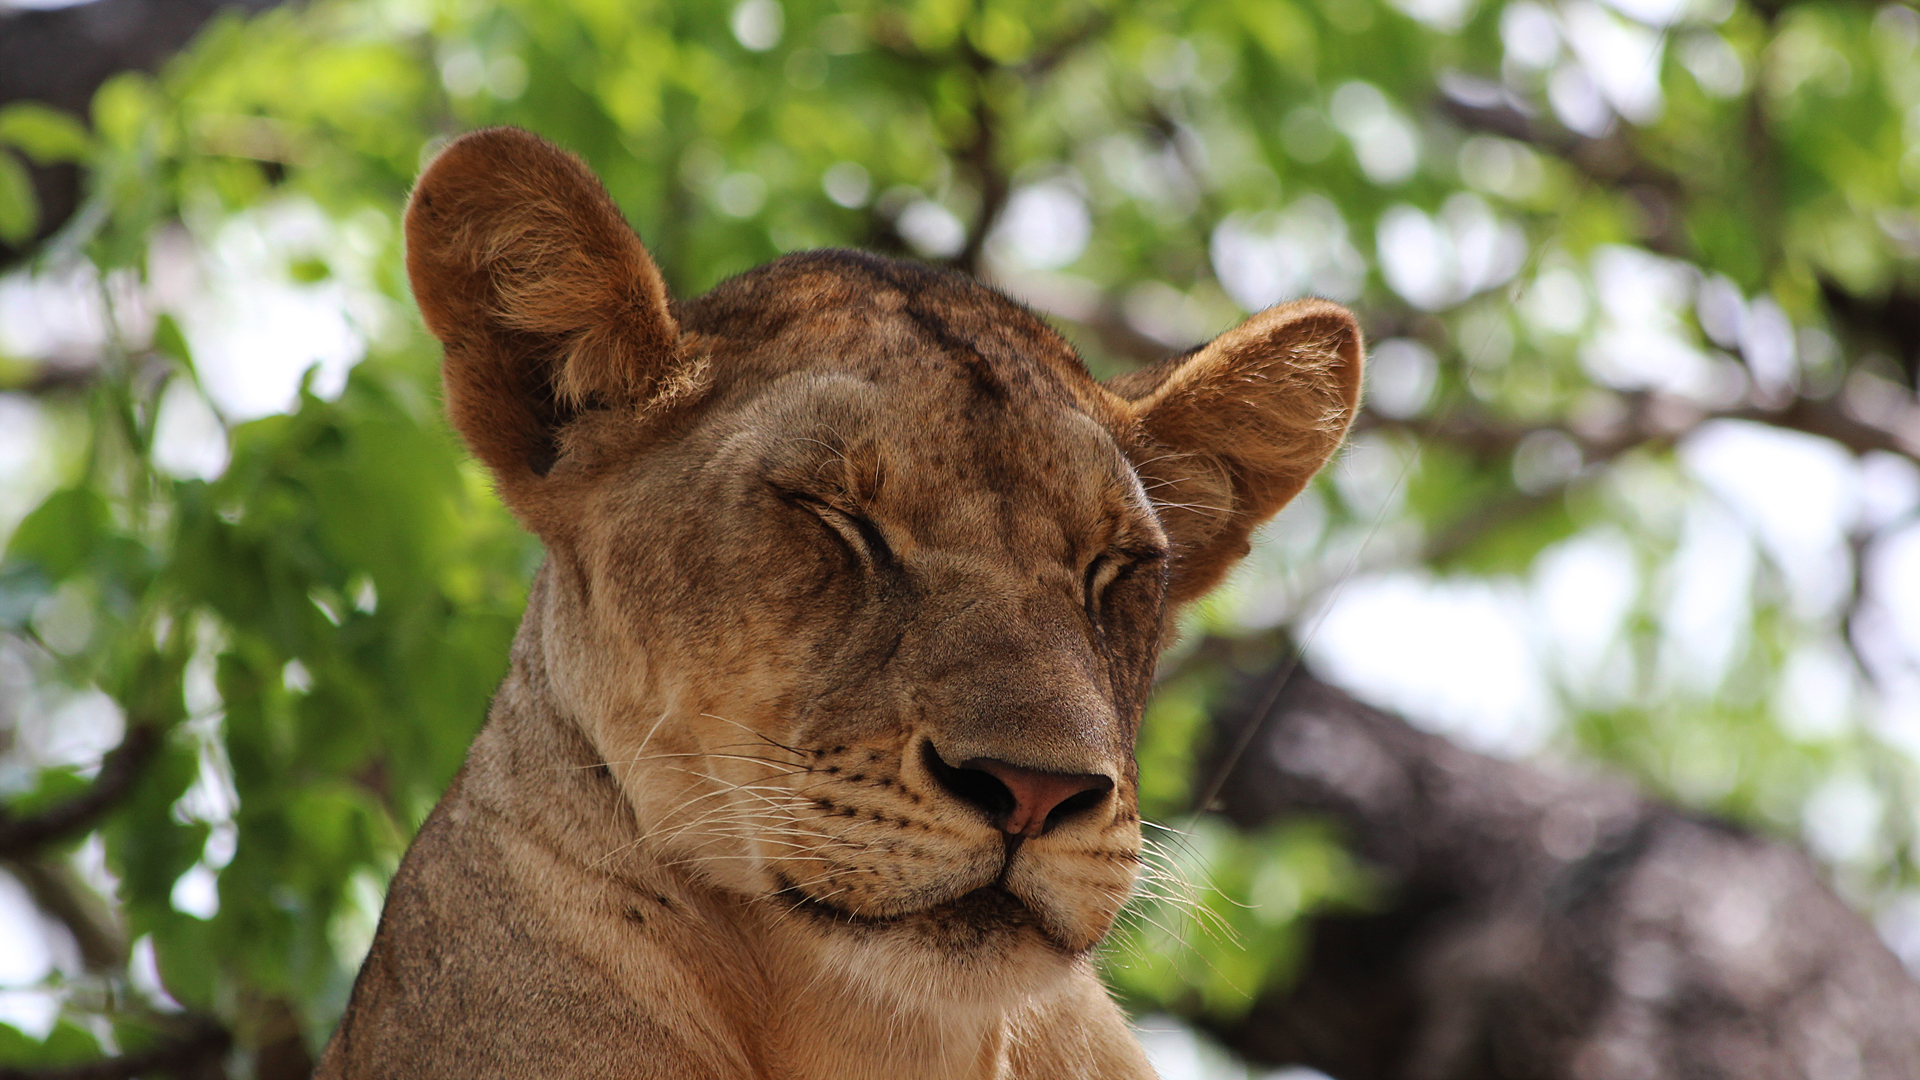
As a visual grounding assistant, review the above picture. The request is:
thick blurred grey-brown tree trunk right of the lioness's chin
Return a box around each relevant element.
[1212,669,1920,1080]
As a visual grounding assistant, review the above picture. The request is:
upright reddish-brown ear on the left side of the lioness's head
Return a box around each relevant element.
[407,127,685,530]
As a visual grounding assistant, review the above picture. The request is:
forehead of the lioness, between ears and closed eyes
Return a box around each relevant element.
[687,252,1140,546]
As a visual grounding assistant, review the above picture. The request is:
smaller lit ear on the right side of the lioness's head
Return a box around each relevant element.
[1108,300,1361,603]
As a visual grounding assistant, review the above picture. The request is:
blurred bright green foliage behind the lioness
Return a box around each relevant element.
[0,0,1920,1068]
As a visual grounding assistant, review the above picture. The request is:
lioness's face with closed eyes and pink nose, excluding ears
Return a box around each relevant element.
[549,272,1167,953]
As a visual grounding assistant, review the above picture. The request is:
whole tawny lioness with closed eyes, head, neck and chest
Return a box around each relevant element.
[319,129,1361,1080]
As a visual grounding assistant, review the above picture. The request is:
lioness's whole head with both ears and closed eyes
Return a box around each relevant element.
[407,129,1361,999]
